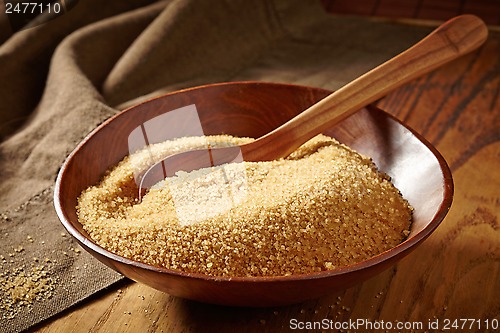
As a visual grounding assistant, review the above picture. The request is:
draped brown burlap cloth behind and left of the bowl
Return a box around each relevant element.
[0,0,429,332]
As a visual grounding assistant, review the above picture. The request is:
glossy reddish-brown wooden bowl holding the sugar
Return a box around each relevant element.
[54,82,453,306]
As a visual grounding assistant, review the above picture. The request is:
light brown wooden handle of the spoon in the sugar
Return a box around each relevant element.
[242,15,488,161]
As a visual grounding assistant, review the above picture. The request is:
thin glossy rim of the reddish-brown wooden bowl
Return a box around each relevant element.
[54,81,454,283]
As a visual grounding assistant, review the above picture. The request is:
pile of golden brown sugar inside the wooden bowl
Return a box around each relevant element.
[78,135,412,277]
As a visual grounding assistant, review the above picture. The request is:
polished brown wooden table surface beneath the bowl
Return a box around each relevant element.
[33,22,500,333]
